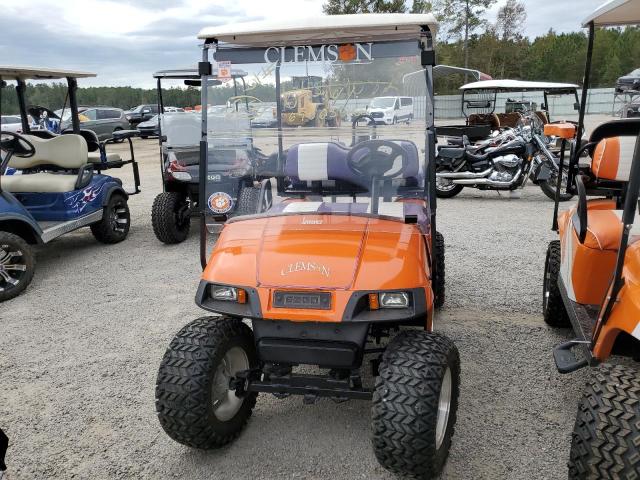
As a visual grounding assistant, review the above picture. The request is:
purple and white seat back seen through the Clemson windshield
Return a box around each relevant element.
[285,140,424,189]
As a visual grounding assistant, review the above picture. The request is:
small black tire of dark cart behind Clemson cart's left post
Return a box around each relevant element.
[151,192,191,245]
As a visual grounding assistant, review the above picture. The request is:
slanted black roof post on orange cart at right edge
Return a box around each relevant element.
[591,135,640,340]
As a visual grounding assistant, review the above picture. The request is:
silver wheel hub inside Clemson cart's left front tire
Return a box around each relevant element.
[211,347,249,422]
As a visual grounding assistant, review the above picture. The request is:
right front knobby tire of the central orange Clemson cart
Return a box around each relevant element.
[372,330,460,479]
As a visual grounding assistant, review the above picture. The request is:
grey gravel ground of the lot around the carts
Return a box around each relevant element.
[0,116,608,480]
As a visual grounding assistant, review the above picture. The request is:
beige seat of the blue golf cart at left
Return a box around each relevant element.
[0,135,91,193]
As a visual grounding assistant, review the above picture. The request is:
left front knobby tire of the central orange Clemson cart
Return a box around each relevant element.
[156,317,258,449]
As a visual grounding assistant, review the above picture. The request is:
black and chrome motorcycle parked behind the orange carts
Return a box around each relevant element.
[436,113,573,201]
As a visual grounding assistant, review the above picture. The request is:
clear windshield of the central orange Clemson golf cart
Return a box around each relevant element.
[202,43,428,232]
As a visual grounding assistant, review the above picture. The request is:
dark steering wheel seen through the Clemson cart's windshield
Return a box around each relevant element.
[347,140,407,180]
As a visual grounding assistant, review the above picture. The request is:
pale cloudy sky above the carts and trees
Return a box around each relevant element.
[0,0,603,88]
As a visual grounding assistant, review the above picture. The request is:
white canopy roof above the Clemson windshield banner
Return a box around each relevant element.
[198,13,438,47]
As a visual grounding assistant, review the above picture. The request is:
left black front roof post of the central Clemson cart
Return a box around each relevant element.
[198,44,212,270]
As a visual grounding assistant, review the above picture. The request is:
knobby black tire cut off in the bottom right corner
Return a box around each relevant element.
[569,364,640,480]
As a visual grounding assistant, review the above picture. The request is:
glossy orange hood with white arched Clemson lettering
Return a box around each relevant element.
[203,215,428,290]
